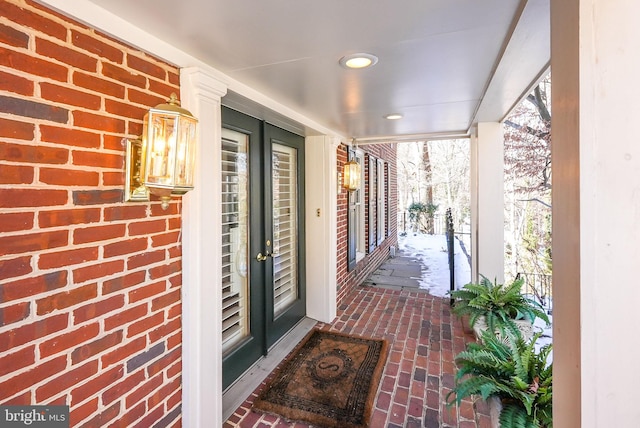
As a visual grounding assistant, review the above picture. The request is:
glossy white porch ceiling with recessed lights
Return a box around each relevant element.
[75,0,549,141]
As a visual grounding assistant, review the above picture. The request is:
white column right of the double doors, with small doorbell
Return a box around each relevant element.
[305,136,340,323]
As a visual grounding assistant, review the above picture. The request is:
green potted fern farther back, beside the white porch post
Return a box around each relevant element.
[451,276,549,331]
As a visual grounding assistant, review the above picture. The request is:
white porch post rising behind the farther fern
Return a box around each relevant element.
[471,122,504,283]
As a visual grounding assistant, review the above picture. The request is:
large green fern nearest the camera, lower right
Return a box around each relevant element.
[447,329,553,428]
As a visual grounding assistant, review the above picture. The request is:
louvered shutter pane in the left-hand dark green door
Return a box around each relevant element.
[222,129,249,352]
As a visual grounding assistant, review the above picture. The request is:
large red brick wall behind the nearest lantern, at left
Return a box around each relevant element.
[0,0,182,427]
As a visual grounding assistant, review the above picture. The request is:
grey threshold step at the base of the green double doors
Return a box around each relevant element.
[222,317,317,421]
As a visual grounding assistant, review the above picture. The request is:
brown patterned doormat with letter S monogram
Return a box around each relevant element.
[253,330,387,428]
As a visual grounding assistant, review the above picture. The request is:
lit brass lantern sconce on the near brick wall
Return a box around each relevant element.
[125,94,198,209]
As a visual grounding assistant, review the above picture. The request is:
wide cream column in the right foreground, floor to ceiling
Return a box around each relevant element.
[551,0,640,428]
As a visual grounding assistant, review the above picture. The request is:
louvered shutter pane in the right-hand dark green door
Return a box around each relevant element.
[272,143,298,317]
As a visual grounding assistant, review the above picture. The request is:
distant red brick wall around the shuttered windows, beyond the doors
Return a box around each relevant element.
[336,143,398,306]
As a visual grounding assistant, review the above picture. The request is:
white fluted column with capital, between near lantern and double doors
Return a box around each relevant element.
[180,68,227,428]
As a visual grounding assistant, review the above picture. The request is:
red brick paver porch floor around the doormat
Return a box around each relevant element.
[224,287,491,428]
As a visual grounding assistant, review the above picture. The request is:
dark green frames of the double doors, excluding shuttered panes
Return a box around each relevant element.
[222,106,306,389]
